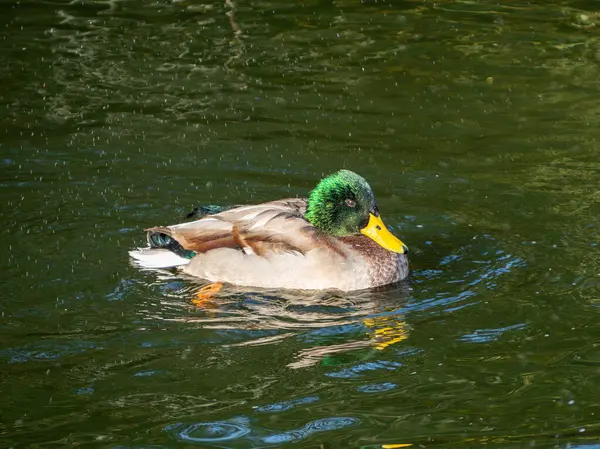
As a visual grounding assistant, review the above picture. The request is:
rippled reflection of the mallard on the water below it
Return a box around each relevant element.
[141,273,410,368]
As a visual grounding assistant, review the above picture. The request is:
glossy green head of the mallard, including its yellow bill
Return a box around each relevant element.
[305,170,408,254]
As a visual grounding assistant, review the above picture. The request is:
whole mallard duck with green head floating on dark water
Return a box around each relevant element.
[129,170,408,291]
